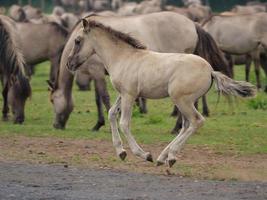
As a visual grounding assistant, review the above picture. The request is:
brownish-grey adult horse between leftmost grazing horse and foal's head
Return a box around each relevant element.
[15,22,68,81]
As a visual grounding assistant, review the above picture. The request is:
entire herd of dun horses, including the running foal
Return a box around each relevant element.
[0,0,267,166]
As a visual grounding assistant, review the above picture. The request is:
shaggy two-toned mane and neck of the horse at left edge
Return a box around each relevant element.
[0,18,31,97]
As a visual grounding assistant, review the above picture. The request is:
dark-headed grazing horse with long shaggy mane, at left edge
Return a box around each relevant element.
[0,16,31,124]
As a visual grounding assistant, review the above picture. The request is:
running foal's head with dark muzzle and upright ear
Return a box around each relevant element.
[67,19,94,72]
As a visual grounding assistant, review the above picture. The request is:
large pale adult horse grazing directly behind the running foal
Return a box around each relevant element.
[50,12,229,131]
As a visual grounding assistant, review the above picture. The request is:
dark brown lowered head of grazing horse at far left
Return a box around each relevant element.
[8,76,31,124]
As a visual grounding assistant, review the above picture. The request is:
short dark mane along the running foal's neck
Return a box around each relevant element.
[88,20,147,49]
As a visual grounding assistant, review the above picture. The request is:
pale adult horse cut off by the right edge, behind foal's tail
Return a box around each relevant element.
[203,13,267,88]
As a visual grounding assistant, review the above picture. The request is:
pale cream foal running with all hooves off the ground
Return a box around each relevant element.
[66,19,256,167]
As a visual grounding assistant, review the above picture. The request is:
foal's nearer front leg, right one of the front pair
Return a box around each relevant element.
[120,95,153,162]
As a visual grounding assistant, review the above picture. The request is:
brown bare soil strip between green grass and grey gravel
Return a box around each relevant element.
[0,136,267,182]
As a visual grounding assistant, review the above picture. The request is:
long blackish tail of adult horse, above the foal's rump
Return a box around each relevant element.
[194,24,233,77]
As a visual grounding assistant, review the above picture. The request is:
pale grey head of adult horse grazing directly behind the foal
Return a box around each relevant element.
[47,81,73,129]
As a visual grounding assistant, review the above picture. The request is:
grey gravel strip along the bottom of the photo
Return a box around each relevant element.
[0,162,267,200]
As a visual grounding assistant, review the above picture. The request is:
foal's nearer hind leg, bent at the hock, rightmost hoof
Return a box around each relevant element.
[167,98,204,167]
